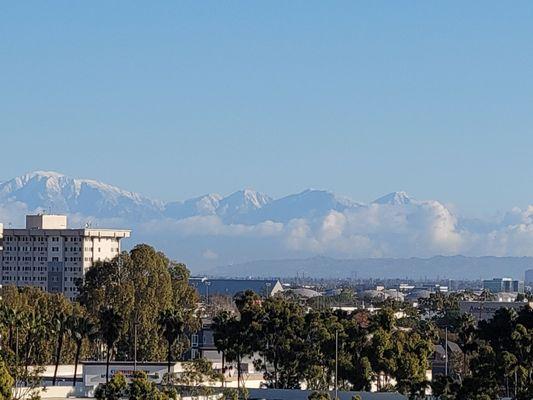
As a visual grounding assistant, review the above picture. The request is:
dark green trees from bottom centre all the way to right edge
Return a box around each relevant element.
[213,292,533,400]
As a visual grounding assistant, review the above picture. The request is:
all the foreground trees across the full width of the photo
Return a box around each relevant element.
[0,245,533,400]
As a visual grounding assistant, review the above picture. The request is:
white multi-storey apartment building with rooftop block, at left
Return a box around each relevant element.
[0,214,131,299]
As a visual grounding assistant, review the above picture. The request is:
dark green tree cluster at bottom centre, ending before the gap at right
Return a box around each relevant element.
[213,291,436,395]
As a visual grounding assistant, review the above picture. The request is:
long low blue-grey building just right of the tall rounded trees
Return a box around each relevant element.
[189,278,283,297]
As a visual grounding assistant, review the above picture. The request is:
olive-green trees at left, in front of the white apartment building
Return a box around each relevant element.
[0,245,199,396]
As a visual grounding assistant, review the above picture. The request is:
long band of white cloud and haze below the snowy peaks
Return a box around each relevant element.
[7,196,533,264]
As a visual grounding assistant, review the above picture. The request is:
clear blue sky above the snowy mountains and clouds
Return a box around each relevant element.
[0,1,533,213]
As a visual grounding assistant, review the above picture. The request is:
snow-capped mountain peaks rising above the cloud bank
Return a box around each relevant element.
[0,171,412,225]
